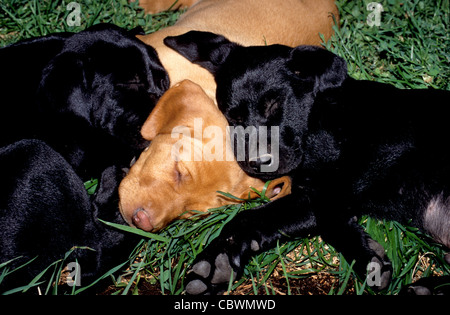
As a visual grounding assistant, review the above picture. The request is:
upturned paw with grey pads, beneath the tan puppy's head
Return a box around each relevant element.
[186,253,237,295]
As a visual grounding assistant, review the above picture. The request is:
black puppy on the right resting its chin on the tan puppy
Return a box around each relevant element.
[165,32,450,294]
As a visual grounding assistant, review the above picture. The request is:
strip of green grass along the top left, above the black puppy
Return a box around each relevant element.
[0,0,180,47]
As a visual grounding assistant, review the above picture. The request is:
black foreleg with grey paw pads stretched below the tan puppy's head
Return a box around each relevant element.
[186,194,316,295]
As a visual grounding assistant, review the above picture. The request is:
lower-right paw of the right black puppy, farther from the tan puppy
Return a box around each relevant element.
[366,239,392,291]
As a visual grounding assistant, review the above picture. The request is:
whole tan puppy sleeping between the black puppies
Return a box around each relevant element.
[120,0,338,230]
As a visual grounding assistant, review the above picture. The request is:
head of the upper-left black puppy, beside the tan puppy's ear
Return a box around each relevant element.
[38,24,169,172]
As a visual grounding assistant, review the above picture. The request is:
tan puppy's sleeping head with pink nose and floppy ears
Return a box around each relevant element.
[119,81,291,230]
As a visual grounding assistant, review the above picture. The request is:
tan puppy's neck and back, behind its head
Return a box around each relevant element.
[138,0,338,100]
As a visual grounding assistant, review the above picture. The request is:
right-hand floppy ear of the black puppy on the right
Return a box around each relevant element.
[289,46,348,91]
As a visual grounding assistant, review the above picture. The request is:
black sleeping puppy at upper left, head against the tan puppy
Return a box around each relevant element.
[0,24,169,179]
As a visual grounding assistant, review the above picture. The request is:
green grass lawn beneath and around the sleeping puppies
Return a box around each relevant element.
[0,0,450,295]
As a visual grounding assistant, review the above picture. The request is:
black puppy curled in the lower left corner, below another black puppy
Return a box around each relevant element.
[0,140,137,294]
